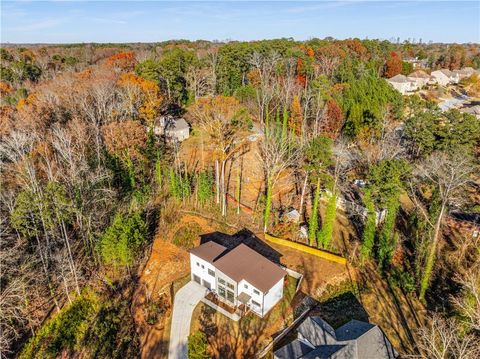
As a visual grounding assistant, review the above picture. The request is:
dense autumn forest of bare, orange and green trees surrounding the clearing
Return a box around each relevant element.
[0,38,480,358]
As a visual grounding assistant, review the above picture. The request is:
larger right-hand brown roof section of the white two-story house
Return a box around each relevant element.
[213,242,286,293]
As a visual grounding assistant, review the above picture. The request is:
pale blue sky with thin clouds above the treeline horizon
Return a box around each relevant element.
[0,0,480,43]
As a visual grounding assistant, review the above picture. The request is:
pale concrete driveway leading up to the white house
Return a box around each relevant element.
[168,281,207,359]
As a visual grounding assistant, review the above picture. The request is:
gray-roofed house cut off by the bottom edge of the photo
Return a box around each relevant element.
[273,317,398,359]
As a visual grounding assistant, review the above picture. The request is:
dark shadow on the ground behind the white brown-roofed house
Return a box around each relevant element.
[200,229,282,264]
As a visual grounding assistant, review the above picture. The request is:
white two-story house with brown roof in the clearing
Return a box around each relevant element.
[190,241,287,317]
